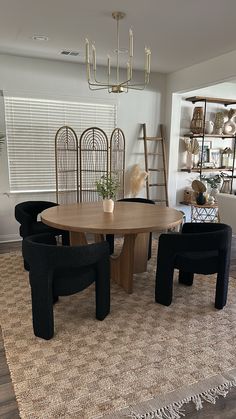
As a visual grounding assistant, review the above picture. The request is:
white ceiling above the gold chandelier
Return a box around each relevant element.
[0,0,236,73]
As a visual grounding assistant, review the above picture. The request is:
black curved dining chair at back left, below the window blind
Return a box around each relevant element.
[15,201,69,269]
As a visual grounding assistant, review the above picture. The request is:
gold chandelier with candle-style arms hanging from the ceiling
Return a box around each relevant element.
[85,12,151,93]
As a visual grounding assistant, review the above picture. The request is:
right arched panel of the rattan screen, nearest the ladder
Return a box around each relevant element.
[110,128,125,199]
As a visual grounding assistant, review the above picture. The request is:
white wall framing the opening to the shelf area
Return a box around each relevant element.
[166,50,236,206]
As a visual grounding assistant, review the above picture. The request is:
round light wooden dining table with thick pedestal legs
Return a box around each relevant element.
[41,201,183,293]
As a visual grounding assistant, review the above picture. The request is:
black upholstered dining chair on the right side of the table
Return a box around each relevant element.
[155,223,232,309]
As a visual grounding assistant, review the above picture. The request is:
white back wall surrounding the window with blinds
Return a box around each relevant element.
[0,55,166,241]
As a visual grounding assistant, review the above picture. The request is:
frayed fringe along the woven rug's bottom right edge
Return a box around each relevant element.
[126,379,236,419]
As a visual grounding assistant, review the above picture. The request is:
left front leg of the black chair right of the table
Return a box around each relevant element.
[155,260,174,306]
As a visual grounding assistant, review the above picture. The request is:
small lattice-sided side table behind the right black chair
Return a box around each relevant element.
[191,202,219,223]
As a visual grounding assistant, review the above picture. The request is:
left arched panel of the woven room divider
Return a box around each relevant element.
[55,126,79,204]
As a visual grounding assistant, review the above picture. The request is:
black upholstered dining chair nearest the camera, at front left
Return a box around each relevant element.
[22,233,110,339]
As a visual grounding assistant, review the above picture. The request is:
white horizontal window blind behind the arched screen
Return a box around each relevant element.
[5,97,116,192]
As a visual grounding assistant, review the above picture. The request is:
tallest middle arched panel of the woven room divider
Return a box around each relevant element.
[79,127,109,202]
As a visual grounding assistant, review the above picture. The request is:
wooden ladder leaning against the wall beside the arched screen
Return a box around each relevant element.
[142,124,169,207]
